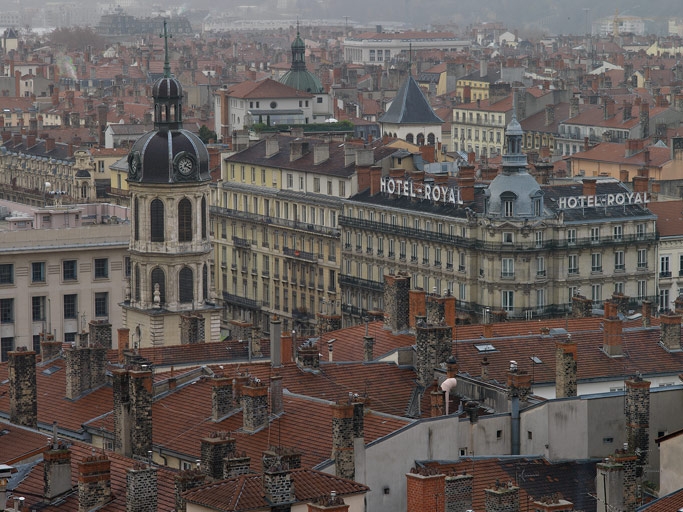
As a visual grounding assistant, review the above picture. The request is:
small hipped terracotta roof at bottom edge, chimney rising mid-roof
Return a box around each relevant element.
[184,469,369,512]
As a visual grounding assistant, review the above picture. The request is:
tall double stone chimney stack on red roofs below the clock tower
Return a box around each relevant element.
[112,369,154,458]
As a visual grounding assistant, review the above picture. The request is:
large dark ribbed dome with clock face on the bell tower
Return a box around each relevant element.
[128,128,211,183]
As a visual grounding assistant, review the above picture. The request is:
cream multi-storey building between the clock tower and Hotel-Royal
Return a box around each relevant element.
[211,135,396,335]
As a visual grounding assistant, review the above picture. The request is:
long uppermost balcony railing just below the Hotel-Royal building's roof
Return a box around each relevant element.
[339,215,657,252]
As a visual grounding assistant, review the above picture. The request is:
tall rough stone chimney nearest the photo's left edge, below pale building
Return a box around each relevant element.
[7,351,38,428]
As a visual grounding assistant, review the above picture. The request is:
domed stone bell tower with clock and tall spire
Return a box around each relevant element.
[123,22,220,347]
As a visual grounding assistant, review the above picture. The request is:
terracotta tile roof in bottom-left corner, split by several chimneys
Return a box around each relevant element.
[14,437,176,512]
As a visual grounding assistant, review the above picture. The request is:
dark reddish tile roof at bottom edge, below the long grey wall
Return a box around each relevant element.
[422,457,599,512]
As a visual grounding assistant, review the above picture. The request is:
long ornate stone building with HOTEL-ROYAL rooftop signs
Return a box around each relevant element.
[339,118,657,323]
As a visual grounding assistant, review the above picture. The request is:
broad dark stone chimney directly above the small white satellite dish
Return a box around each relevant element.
[415,324,453,387]
